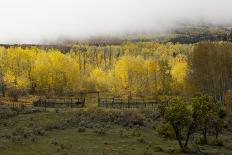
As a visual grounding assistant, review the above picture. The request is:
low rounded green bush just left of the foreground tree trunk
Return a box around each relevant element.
[157,123,175,138]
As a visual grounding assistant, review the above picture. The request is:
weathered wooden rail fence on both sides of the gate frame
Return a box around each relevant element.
[1,97,160,110]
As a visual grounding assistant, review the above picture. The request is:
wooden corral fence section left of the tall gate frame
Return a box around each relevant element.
[33,98,85,108]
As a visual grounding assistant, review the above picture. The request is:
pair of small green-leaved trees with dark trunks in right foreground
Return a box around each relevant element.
[159,94,225,150]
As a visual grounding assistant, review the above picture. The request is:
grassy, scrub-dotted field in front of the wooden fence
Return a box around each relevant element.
[0,103,232,155]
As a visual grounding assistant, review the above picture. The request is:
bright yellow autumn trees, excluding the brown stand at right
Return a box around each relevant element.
[0,42,191,96]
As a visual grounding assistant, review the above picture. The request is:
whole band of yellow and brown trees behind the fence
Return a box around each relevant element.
[0,42,232,100]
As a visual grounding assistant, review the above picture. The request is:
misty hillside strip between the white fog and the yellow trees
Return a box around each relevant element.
[0,25,232,52]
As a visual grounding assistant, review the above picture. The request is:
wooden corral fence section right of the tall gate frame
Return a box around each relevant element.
[98,98,159,110]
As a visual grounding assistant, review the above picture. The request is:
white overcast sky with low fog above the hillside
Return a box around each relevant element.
[0,0,232,43]
